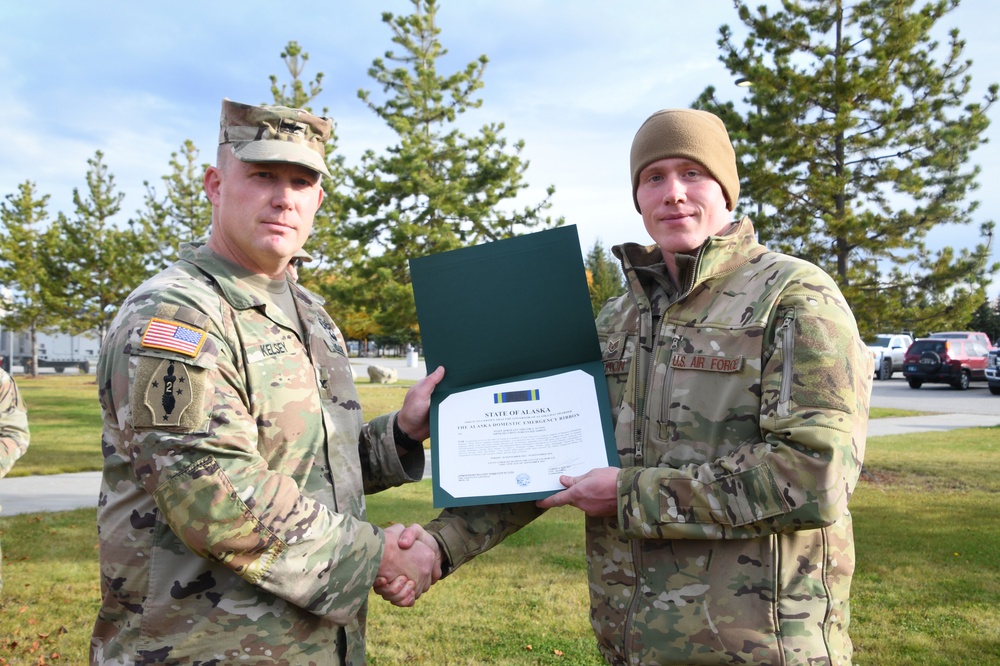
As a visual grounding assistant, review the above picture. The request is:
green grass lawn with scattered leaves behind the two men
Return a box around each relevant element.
[0,375,1000,666]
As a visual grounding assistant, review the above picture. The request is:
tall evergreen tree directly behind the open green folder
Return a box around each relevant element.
[344,0,562,343]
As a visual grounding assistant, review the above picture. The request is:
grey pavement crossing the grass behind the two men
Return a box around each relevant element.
[0,359,1000,516]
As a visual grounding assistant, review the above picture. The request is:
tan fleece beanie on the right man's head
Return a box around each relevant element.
[630,109,740,212]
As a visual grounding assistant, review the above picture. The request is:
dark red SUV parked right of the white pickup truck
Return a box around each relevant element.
[903,338,989,390]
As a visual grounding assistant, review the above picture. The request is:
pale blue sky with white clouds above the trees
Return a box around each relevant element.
[0,0,1000,295]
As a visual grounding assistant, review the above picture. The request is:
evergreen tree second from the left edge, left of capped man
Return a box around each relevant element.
[54,151,148,340]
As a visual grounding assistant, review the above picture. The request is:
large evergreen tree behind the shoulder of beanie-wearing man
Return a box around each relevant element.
[696,0,997,335]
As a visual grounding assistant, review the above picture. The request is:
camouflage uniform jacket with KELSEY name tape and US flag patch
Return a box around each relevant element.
[91,246,424,665]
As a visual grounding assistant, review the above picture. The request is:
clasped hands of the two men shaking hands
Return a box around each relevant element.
[373,523,444,606]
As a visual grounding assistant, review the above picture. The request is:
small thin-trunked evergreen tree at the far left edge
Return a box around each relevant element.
[0,180,58,376]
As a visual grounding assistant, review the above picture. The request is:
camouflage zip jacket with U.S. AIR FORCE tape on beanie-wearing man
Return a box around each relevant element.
[429,219,873,666]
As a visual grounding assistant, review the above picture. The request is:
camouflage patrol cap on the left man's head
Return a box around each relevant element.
[219,99,332,177]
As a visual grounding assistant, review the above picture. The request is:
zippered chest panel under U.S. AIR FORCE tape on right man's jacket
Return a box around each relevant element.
[649,326,761,466]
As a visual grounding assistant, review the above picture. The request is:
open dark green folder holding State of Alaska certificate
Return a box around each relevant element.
[410,226,618,507]
